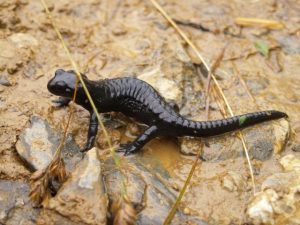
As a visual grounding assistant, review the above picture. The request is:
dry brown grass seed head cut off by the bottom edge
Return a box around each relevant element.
[111,195,136,225]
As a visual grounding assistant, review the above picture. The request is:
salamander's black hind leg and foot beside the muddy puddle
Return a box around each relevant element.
[117,126,158,155]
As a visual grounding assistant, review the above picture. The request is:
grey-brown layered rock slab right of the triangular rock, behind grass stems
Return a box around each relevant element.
[103,155,206,225]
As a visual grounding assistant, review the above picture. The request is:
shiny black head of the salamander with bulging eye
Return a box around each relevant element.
[47,69,87,98]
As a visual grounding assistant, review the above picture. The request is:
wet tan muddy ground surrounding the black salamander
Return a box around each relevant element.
[0,0,300,224]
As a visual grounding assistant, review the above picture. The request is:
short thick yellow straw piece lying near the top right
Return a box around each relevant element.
[235,17,284,29]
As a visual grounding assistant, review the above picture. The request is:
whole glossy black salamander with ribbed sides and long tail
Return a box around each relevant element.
[47,69,287,155]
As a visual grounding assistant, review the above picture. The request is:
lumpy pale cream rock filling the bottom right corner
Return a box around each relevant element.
[247,155,300,224]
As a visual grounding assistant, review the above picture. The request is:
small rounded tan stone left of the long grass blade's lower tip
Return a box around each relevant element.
[222,171,247,192]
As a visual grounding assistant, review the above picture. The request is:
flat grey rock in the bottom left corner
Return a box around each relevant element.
[0,180,40,225]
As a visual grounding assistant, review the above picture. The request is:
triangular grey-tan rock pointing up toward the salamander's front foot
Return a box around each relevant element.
[46,148,108,225]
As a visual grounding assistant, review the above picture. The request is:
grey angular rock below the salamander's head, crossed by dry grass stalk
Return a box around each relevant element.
[16,116,82,170]
